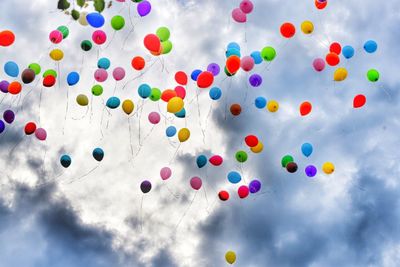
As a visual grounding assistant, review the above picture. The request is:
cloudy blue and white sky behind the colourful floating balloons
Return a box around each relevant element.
[0,0,400,267]
